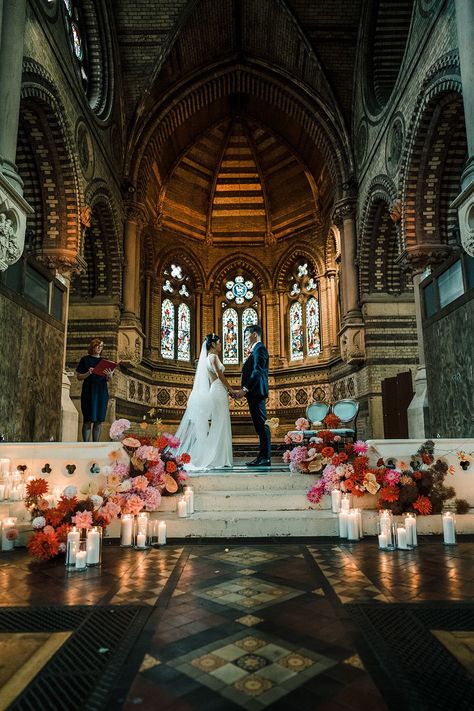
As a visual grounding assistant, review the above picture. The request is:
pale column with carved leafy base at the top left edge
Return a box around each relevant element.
[0,0,32,271]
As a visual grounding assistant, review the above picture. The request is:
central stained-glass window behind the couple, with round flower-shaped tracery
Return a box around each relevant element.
[222,274,258,365]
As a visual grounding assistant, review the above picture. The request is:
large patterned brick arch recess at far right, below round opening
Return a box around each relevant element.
[400,54,467,253]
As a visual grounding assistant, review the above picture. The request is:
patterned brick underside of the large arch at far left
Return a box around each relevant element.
[20,60,84,264]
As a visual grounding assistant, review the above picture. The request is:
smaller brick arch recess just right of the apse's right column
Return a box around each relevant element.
[358,184,406,295]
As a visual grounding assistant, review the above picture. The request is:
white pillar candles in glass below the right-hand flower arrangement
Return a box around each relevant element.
[331,489,456,550]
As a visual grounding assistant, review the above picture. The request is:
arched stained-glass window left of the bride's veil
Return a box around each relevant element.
[161,264,192,363]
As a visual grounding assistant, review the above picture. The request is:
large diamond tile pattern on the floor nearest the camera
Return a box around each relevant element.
[168,631,337,711]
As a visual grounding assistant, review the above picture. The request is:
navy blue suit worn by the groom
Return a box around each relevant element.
[242,341,271,459]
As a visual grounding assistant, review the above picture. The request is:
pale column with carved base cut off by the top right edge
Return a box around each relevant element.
[453,0,474,256]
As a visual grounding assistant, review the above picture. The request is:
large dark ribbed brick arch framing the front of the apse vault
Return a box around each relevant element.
[130,64,352,200]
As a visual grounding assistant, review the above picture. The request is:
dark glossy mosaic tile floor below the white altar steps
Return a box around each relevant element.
[0,538,474,711]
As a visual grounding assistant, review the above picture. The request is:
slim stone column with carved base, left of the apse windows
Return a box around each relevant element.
[118,203,146,364]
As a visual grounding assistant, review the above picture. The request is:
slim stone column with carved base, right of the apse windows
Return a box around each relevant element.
[334,198,365,363]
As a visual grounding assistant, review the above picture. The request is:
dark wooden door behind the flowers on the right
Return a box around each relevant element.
[382,371,413,439]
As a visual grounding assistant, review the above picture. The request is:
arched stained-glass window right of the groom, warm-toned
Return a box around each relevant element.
[288,262,321,363]
